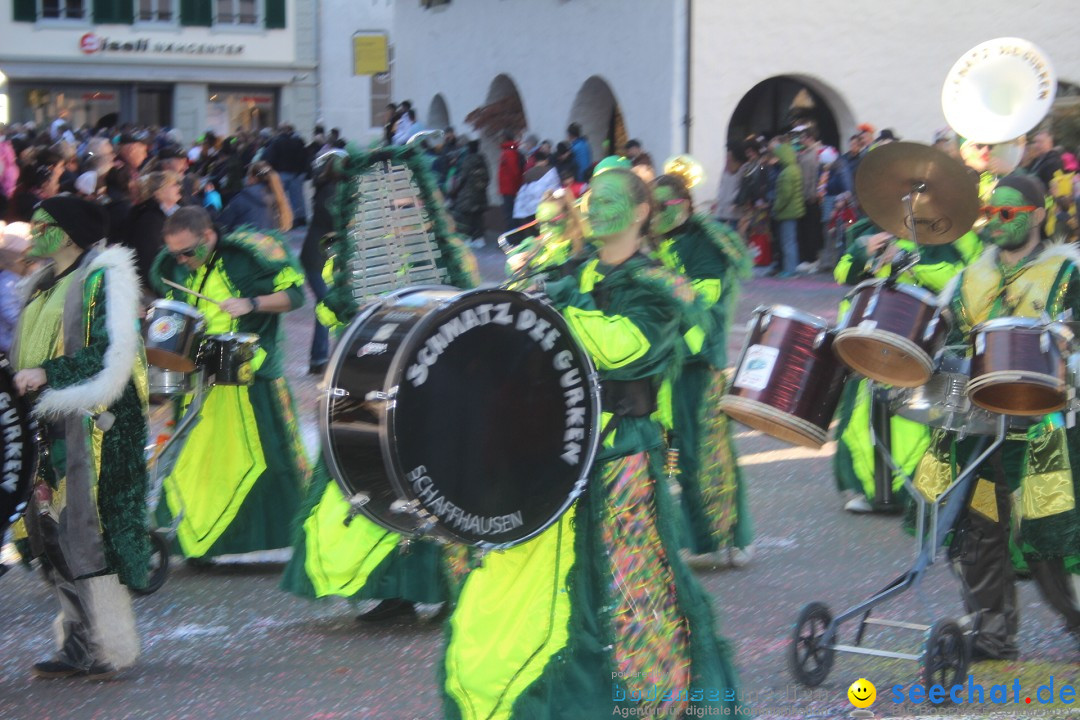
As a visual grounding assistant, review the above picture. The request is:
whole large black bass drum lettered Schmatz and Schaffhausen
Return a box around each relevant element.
[320,286,600,548]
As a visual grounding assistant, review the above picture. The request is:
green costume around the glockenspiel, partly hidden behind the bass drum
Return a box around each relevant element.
[281,140,478,603]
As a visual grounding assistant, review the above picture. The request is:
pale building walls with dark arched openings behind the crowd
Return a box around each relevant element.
[393,0,1080,196]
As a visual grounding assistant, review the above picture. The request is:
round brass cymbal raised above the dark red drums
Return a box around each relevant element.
[855,142,978,245]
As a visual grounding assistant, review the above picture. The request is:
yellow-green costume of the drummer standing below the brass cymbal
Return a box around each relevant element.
[833,225,982,505]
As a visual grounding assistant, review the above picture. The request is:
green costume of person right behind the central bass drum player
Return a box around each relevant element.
[656,215,754,554]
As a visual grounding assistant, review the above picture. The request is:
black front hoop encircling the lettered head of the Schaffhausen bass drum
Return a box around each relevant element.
[380,287,600,549]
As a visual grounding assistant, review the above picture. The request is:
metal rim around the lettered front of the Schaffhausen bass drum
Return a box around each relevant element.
[380,287,603,549]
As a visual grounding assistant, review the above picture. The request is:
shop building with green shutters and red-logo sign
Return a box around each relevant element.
[0,0,318,141]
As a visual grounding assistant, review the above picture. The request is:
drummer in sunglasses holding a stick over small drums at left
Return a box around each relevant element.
[149,207,308,560]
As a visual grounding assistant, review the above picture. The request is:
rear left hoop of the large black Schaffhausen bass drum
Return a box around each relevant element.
[319,285,457,536]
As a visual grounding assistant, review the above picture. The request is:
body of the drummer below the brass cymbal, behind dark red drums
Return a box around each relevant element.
[833,218,983,513]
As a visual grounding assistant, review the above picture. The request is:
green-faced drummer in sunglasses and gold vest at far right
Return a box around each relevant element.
[915,174,1080,660]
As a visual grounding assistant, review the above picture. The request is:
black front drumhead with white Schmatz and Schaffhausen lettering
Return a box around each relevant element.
[384,290,599,547]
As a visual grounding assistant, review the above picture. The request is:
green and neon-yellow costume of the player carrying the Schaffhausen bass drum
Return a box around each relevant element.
[442,254,735,720]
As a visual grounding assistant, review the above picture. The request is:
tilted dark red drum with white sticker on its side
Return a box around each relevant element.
[720,305,848,448]
